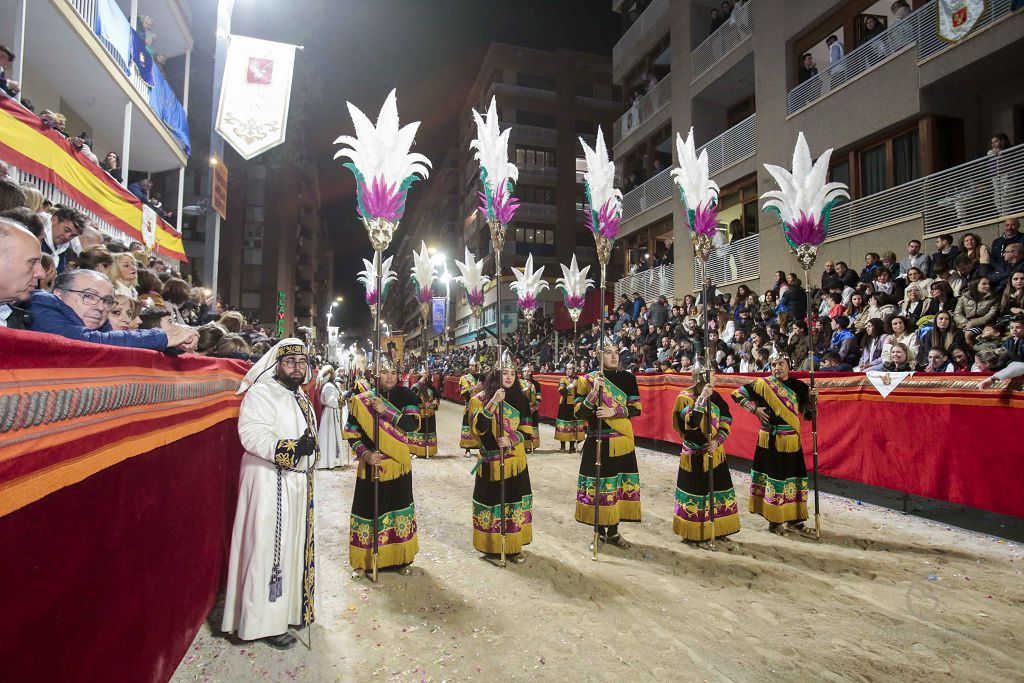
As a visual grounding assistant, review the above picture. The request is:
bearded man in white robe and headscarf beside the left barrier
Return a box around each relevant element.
[221,339,318,649]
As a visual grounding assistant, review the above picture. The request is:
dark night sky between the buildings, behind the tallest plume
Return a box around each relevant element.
[232,0,621,331]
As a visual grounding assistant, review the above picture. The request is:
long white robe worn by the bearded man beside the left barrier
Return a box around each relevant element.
[221,378,309,640]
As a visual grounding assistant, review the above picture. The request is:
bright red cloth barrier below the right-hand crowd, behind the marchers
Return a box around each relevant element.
[445,373,1024,517]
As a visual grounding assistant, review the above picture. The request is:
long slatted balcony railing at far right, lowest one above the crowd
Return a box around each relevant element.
[828,144,1024,239]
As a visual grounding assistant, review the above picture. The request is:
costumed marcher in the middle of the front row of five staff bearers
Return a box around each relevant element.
[575,344,641,550]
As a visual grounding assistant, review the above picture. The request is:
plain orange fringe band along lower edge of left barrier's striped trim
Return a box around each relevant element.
[0,405,239,517]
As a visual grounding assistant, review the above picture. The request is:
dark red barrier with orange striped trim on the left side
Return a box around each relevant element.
[0,329,246,682]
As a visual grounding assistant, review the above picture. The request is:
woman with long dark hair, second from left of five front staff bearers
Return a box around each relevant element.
[469,351,534,564]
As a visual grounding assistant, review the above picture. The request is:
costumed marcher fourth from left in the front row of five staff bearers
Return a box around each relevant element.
[672,371,739,543]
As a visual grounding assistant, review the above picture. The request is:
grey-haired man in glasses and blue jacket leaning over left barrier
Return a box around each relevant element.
[32,270,199,351]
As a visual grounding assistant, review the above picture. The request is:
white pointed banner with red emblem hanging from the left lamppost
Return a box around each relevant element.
[216,36,296,161]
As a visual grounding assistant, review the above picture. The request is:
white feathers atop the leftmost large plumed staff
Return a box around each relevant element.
[334,90,430,187]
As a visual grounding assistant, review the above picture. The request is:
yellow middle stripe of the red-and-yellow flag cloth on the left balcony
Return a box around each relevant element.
[0,97,188,261]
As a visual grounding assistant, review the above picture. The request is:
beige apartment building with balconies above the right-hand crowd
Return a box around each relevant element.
[612,0,1024,297]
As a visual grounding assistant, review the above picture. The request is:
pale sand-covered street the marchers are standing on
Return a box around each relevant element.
[173,402,1024,681]
